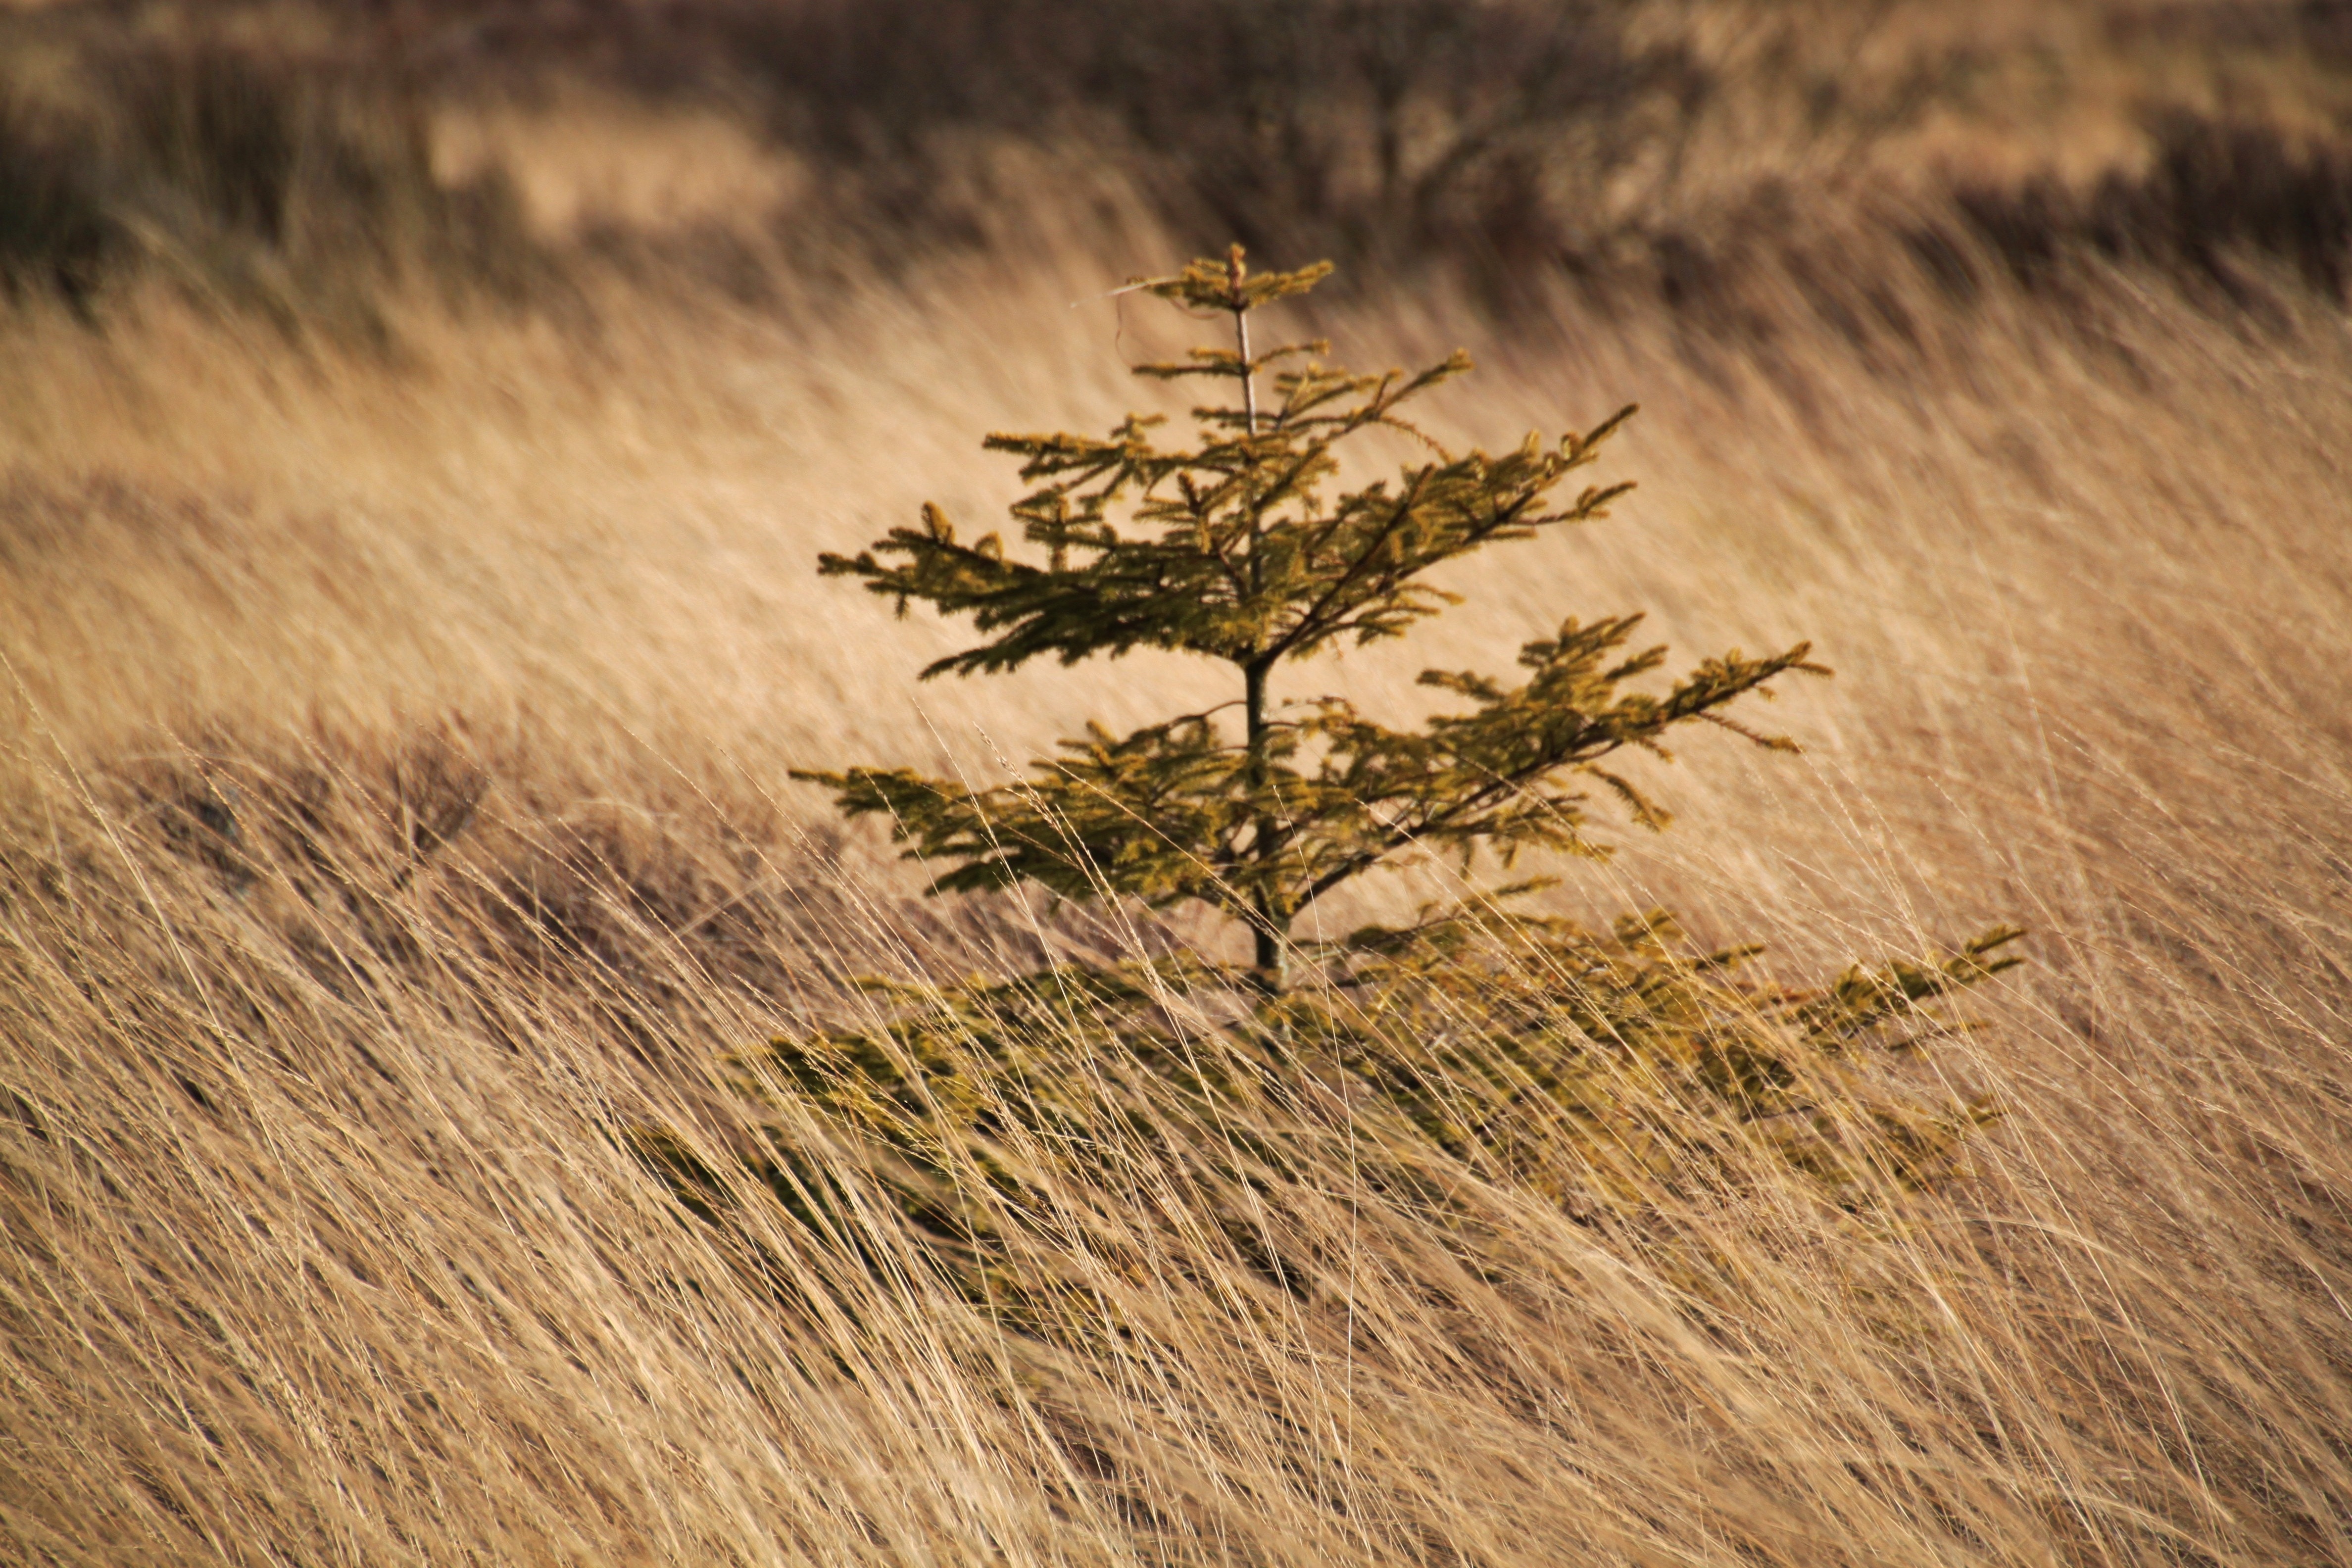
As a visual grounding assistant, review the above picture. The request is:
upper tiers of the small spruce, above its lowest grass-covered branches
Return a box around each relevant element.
[795,247,1818,990]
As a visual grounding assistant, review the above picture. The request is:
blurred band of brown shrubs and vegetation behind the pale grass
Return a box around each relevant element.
[0,0,2352,341]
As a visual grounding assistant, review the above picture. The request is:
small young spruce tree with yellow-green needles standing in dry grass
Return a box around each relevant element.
[640,249,2018,1297]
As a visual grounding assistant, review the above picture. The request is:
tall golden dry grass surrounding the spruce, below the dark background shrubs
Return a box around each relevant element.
[0,12,2352,1566]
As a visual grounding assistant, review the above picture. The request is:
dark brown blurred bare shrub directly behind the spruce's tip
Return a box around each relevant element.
[727,0,1703,272]
